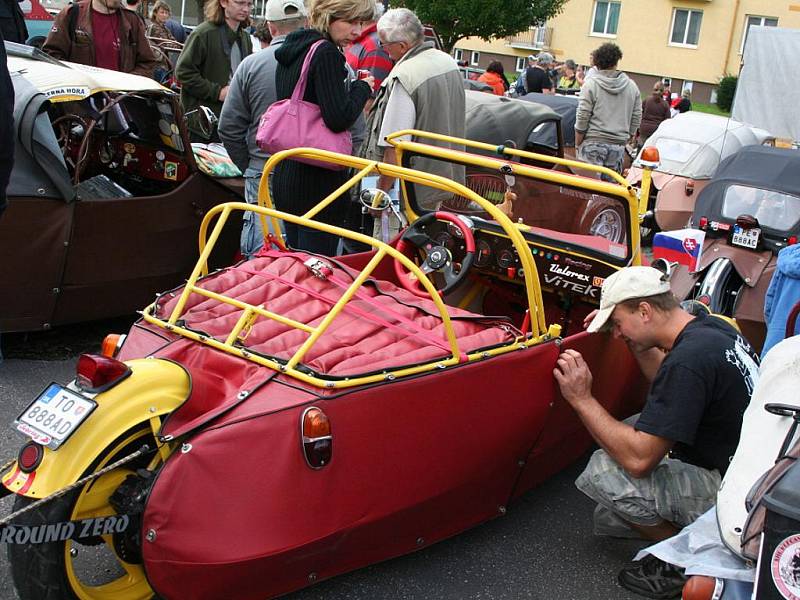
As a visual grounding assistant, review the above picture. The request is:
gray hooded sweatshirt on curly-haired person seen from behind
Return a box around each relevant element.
[575,71,642,145]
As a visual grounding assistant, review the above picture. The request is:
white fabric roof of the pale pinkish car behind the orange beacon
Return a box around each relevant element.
[633,111,773,179]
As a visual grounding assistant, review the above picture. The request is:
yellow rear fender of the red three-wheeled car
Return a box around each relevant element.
[2,359,191,498]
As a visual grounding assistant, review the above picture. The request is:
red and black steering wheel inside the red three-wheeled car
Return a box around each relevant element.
[394,211,475,298]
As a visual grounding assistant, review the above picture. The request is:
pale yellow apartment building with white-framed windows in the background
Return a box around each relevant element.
[454,0,800,102]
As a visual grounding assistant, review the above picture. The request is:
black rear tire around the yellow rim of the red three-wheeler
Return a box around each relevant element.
[8,428,155,600]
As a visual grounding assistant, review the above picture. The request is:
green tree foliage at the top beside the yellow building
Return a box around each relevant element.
[391,0,567,52]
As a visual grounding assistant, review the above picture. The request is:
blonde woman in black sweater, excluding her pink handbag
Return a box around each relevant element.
[272,0,375,256]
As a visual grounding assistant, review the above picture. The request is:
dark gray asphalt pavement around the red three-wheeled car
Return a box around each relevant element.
[0,321,643,600]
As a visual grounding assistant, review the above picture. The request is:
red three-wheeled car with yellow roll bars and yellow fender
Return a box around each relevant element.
[0,138,646,600]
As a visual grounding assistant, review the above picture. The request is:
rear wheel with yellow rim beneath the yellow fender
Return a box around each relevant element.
[8,427,159,600]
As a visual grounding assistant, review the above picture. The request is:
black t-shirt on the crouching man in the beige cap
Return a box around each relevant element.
[636,314,758,474]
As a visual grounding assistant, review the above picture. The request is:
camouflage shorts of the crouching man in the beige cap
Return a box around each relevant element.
[575,450,721,527]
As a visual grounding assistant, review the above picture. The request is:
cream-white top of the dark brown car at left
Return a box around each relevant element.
[8,56,167,102]
